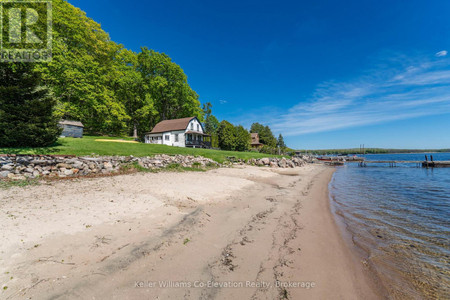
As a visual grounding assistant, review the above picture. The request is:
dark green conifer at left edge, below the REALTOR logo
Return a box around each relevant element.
[0,63,61,147]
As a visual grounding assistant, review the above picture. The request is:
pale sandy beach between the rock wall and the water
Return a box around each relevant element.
[0,165,382,299]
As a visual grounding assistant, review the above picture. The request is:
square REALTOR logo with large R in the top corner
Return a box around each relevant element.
[0,0,52,63]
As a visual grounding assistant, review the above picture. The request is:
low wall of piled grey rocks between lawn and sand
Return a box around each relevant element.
[0,154,310,180]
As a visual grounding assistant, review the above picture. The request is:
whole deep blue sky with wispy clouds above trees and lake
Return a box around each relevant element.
[69,0,450,149]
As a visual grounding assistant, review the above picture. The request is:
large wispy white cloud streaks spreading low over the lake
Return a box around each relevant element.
[241,55,450,136]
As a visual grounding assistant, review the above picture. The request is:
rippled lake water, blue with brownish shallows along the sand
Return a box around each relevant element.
[330,153,450,299]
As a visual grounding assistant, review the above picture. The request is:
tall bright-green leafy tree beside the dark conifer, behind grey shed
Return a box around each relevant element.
[36,0,129,134]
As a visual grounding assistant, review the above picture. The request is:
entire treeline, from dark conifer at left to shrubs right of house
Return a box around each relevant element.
[0,0,286,150]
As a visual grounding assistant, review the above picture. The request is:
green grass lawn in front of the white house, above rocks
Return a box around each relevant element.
[0,136,284,163]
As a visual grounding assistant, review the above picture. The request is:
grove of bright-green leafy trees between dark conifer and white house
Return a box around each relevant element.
[3,0,205,138]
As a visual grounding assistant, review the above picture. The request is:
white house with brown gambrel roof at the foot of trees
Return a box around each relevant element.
[145,117,211,148]
